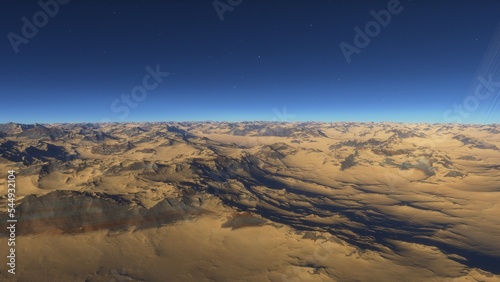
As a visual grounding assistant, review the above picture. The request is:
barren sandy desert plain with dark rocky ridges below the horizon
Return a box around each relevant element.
[0,122,500,281]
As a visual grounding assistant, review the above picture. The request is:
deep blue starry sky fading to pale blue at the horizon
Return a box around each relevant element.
[0,0,500,123]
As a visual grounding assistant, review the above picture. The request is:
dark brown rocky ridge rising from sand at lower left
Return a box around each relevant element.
[3,190,203,235]
